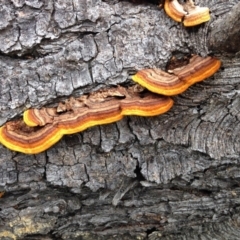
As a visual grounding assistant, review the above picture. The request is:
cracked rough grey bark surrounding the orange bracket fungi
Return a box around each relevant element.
[0,0,240,240]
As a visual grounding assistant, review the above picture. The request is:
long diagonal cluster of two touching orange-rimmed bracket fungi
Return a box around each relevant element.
[0,56,220,154]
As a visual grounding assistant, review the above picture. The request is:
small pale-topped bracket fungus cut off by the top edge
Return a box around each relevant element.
[164,0,210,27]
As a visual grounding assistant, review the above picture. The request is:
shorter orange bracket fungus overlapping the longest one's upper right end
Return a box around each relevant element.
[132,55,221,96]
